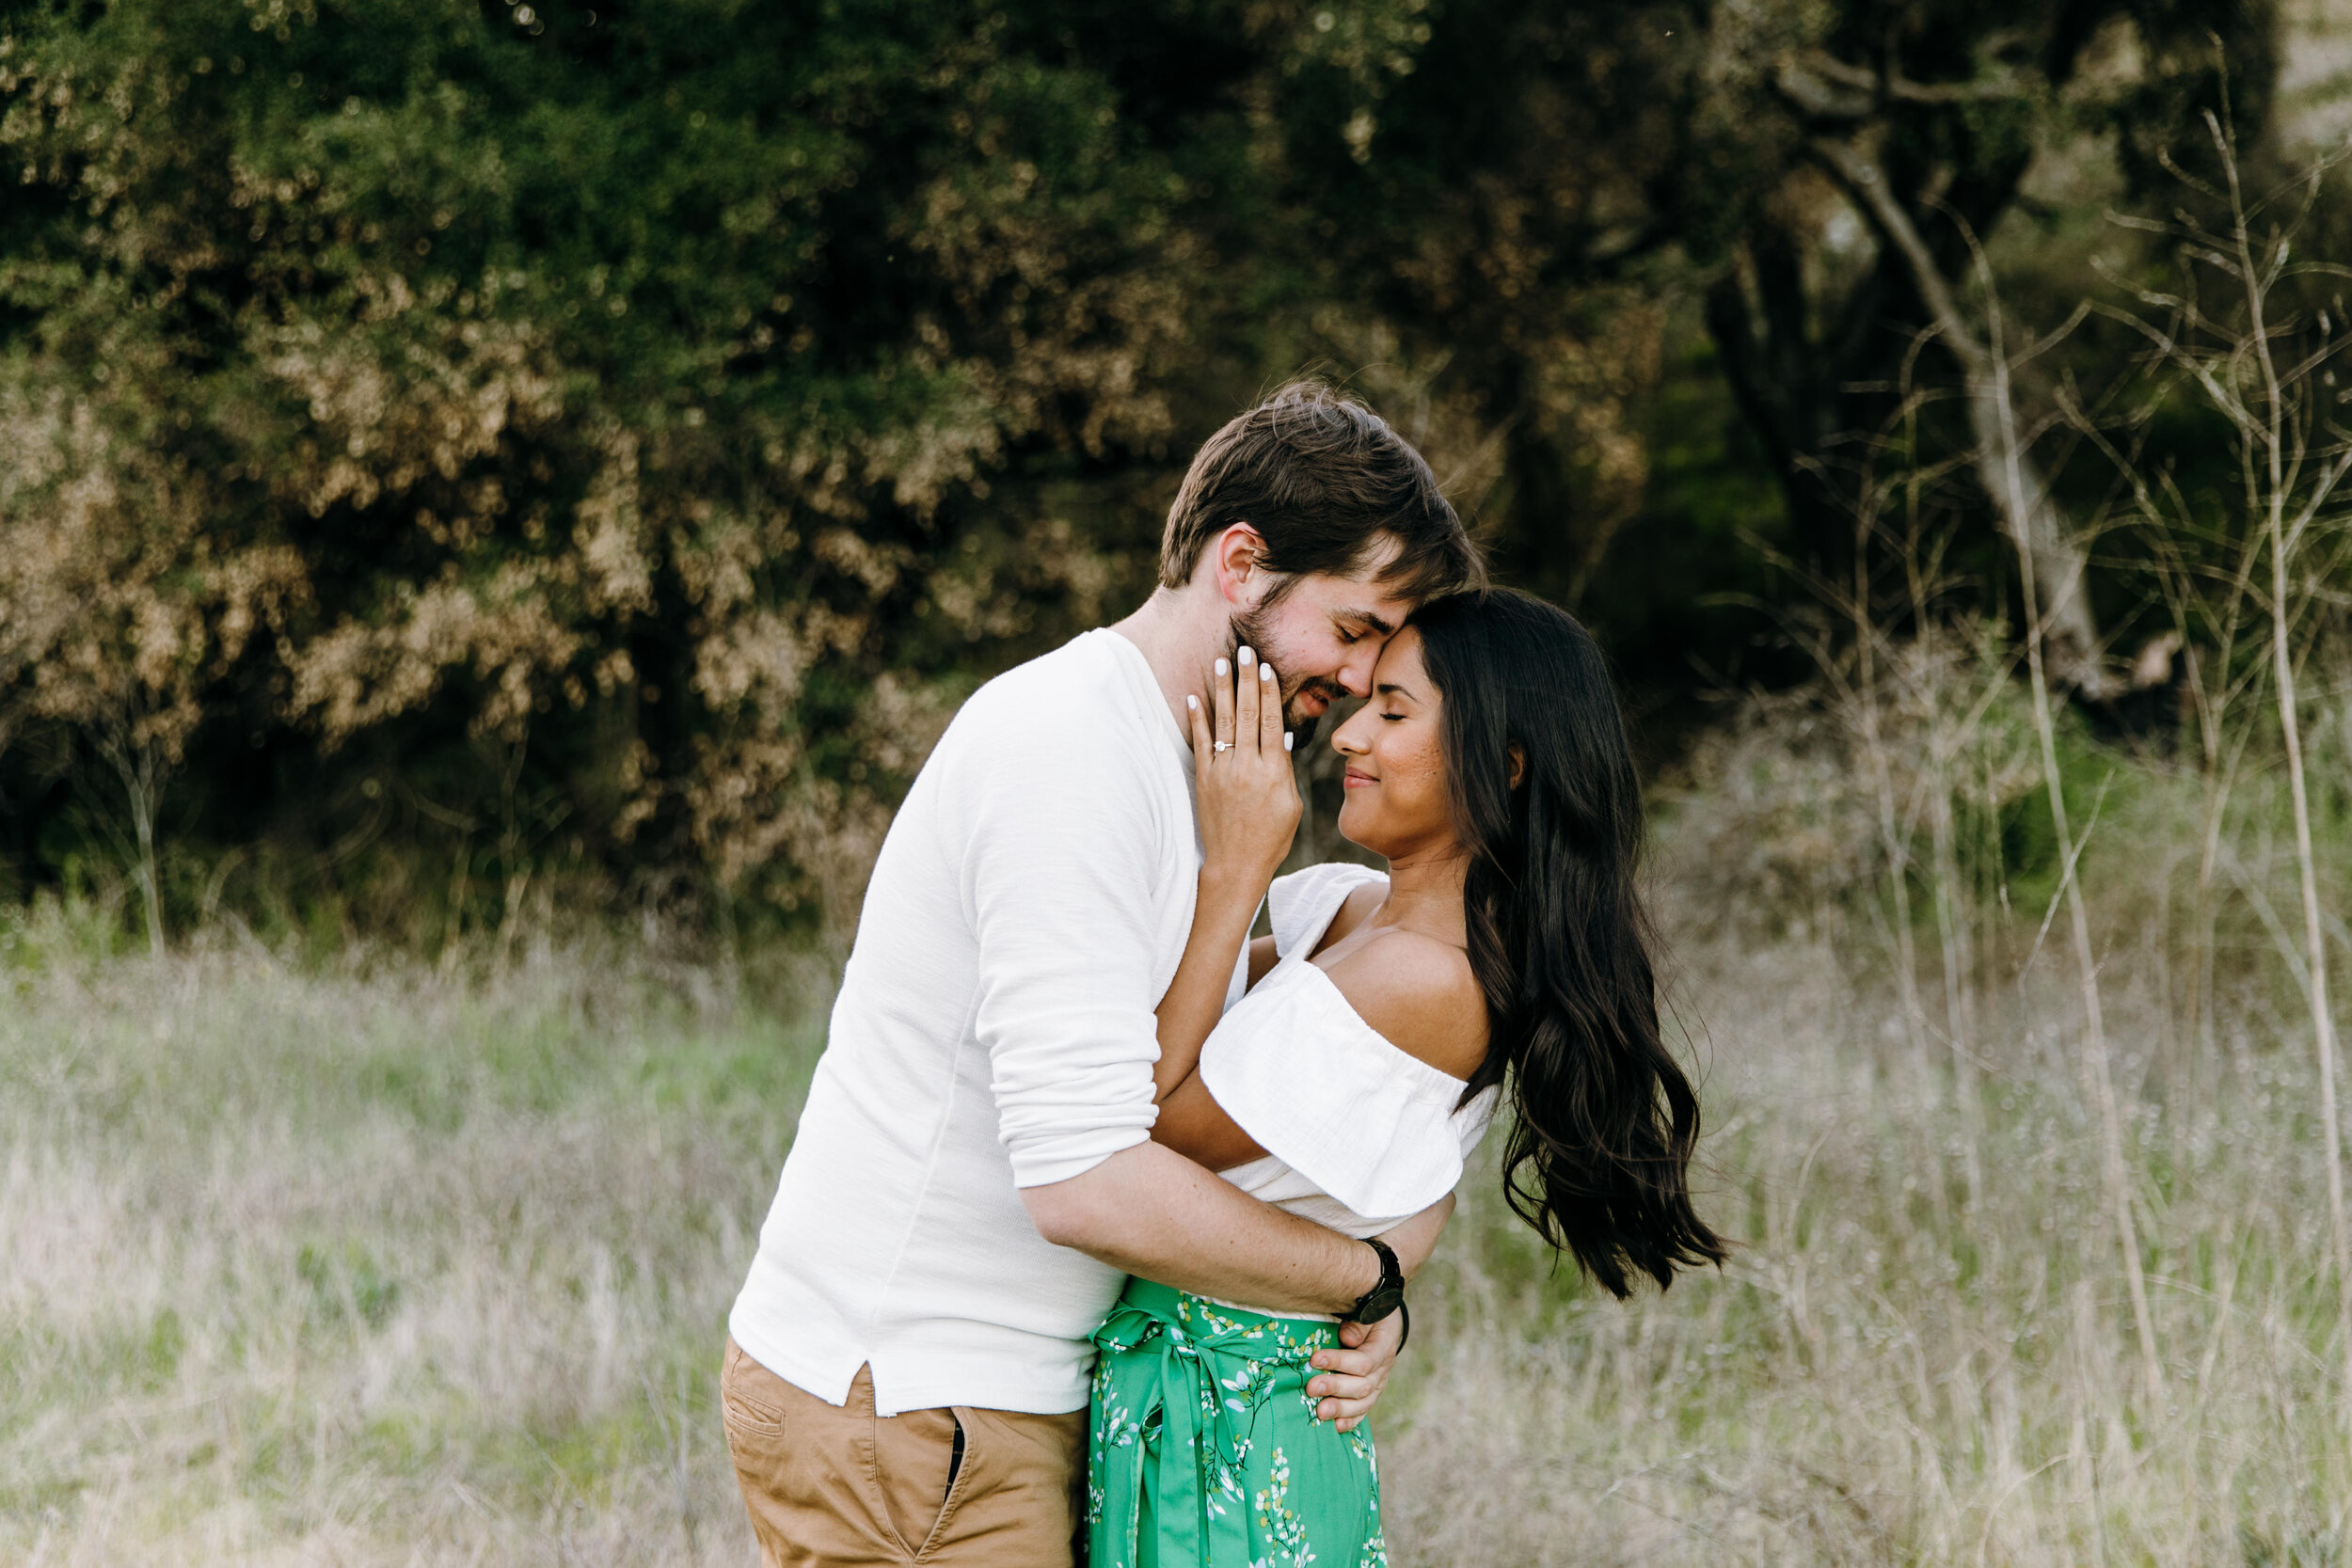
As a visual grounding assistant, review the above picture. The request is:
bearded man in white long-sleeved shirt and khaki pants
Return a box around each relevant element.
[723,383,1480,1568]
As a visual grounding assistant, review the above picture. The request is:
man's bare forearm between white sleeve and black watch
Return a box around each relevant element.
[1021,1143,1383,1312]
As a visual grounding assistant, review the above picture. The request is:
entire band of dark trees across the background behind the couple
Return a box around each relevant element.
[0,0,2333,942]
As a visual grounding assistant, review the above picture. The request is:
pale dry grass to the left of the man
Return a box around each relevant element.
[0,910,818,1563]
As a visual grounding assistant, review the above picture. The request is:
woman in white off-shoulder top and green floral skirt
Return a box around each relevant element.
[1089,590,1724,1568]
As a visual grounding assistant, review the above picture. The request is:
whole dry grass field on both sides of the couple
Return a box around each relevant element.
[0,705,2352,1568]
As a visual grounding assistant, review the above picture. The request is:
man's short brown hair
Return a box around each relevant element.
[1160,381,1486,599]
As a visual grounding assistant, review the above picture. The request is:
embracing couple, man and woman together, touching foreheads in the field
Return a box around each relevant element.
[723,386,1722,1568]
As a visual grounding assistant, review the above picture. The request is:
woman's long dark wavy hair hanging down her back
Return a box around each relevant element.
[1411,588,1724,1298]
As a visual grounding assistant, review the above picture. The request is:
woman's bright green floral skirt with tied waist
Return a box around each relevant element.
[1087,1279,1388,1568]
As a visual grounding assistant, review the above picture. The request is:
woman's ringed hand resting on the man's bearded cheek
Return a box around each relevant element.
[1185,649,1298,889]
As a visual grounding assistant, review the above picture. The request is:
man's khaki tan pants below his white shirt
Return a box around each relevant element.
[720,1336,1087,1568]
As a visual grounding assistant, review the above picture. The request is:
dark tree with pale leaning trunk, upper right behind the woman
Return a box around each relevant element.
[1270,0,2275,696]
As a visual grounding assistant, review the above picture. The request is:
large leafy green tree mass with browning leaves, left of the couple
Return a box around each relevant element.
[0,2,1193,926]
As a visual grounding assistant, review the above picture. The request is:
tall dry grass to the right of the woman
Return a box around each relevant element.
[1388,627,2352,1566]
